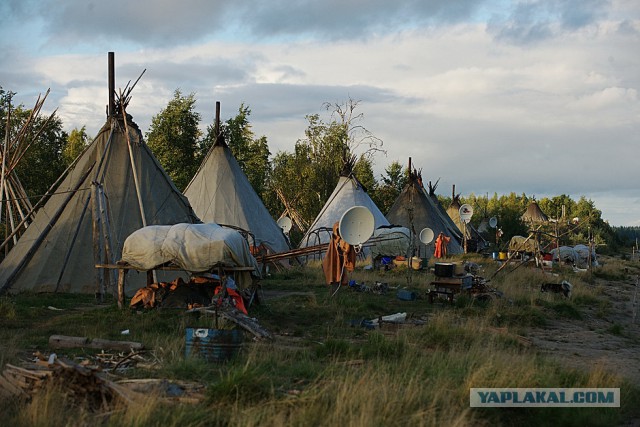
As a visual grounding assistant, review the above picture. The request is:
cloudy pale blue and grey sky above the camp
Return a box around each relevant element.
[0,0,640,226]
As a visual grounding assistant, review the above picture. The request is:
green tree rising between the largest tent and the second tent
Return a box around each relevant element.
[146,89,201,190]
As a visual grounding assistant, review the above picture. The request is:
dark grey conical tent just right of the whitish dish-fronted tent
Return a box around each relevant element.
[387,173,464,255]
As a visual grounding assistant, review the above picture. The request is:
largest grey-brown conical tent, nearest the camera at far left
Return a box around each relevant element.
[0,115,198,293]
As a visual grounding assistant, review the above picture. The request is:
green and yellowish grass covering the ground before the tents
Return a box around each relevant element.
[0,257,640,426]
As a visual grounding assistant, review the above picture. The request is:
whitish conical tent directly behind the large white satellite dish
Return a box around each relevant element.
[300,174,389,248]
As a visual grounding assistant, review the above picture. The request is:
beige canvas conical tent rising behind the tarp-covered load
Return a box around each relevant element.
[184,104,289,253]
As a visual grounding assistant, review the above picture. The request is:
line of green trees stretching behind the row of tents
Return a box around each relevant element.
[0,87,640,251]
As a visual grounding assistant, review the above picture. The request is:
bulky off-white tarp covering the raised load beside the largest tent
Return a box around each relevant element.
[122,223,259,274]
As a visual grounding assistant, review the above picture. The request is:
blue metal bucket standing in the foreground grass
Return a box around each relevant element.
[185,328,242,362]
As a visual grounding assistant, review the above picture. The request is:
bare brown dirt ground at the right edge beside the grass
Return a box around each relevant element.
[527,273,640,386]
